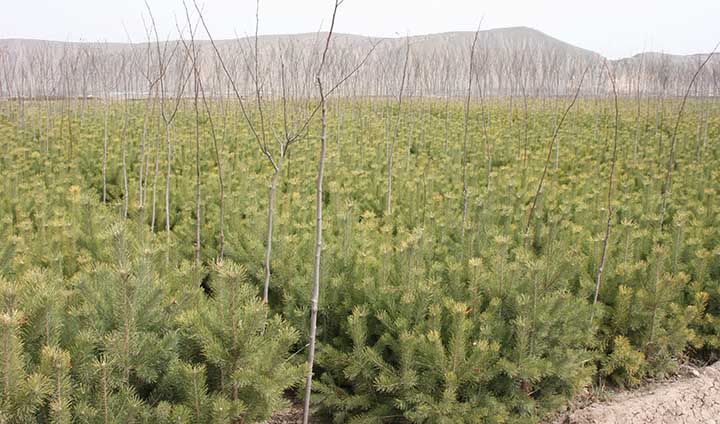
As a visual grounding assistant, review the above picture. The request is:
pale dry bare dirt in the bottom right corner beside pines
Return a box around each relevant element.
[554,362,720,424]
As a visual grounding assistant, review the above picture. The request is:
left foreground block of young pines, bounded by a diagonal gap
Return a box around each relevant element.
[0,115,302,423]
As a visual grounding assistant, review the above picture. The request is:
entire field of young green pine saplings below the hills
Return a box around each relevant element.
[0,97,720,424]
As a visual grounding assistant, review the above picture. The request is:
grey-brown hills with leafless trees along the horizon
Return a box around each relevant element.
[0,27,720,97]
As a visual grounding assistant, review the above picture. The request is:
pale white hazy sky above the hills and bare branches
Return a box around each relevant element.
[0,0,720,58]
